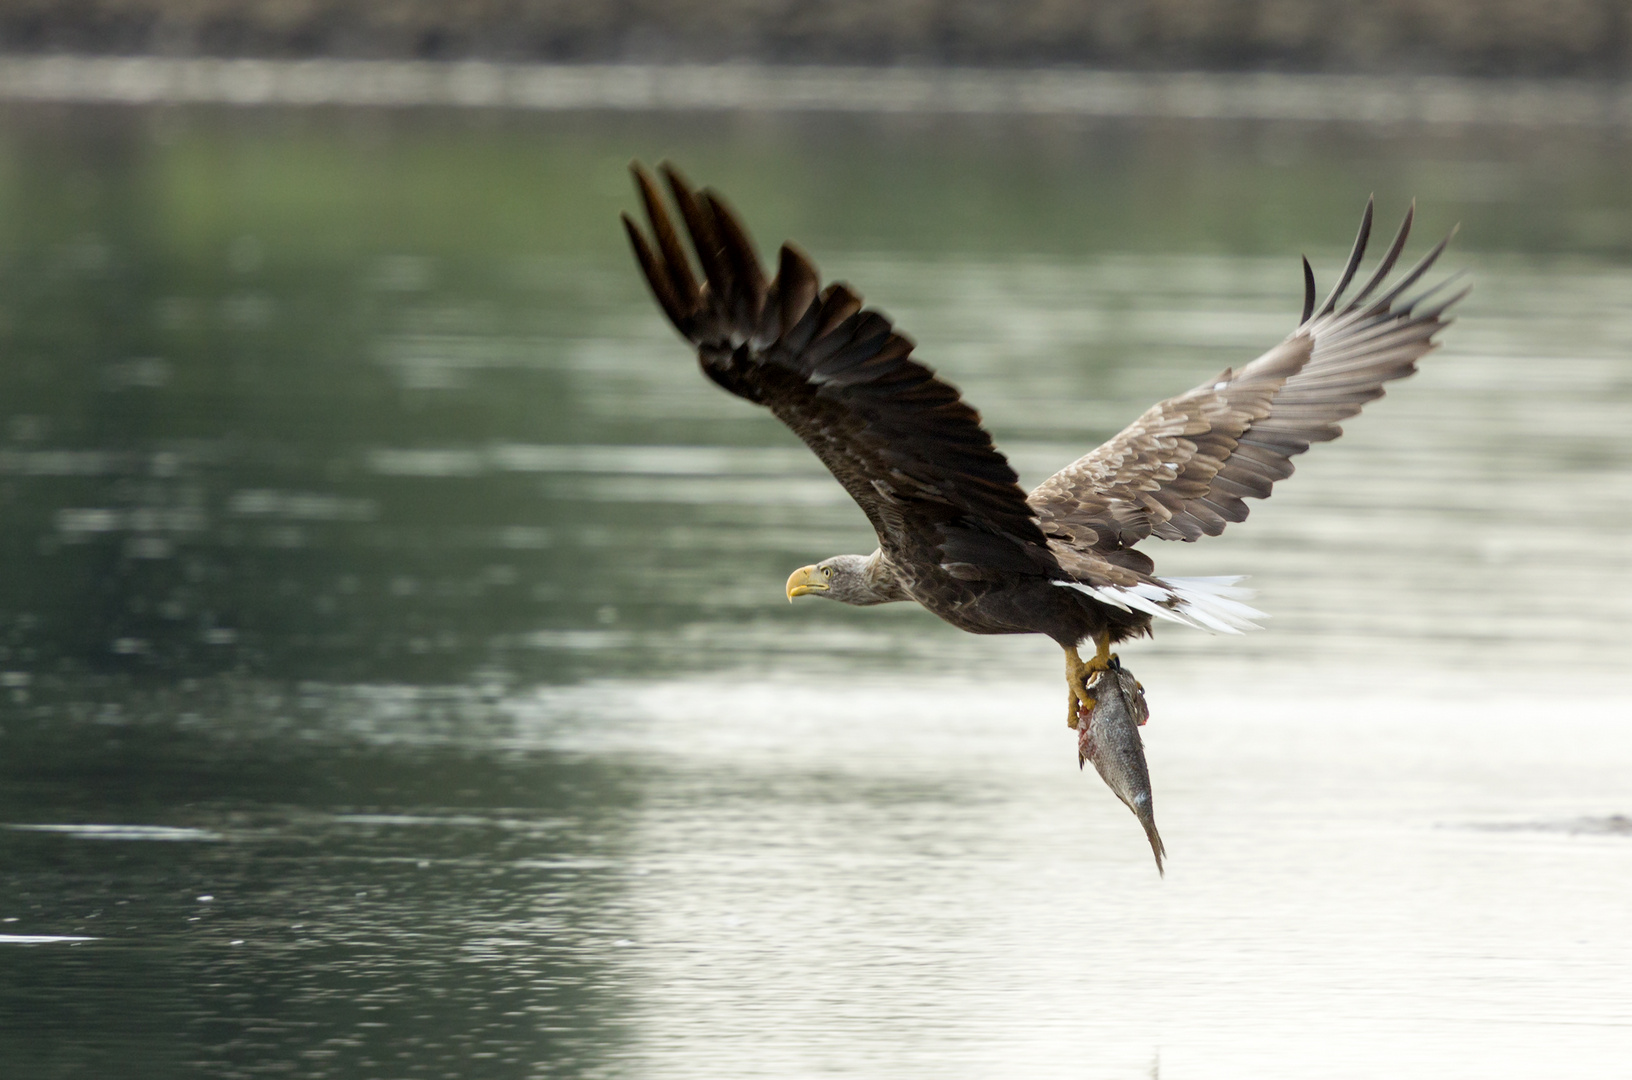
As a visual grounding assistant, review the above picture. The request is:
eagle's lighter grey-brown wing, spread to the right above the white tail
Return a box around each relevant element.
[1030,202,1467,569]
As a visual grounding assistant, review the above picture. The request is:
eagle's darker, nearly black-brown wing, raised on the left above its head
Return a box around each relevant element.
[623,163,1059,579]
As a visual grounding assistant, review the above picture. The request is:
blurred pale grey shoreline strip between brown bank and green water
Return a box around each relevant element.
[0,55,1632,129]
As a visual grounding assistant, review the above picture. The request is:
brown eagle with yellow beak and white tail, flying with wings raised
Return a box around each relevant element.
[623,163,1467,726]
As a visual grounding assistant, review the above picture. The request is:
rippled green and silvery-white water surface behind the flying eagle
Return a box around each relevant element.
[0,109,1632,1078]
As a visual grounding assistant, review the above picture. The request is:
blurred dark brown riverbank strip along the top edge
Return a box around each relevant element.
[0,0,1632,77]
